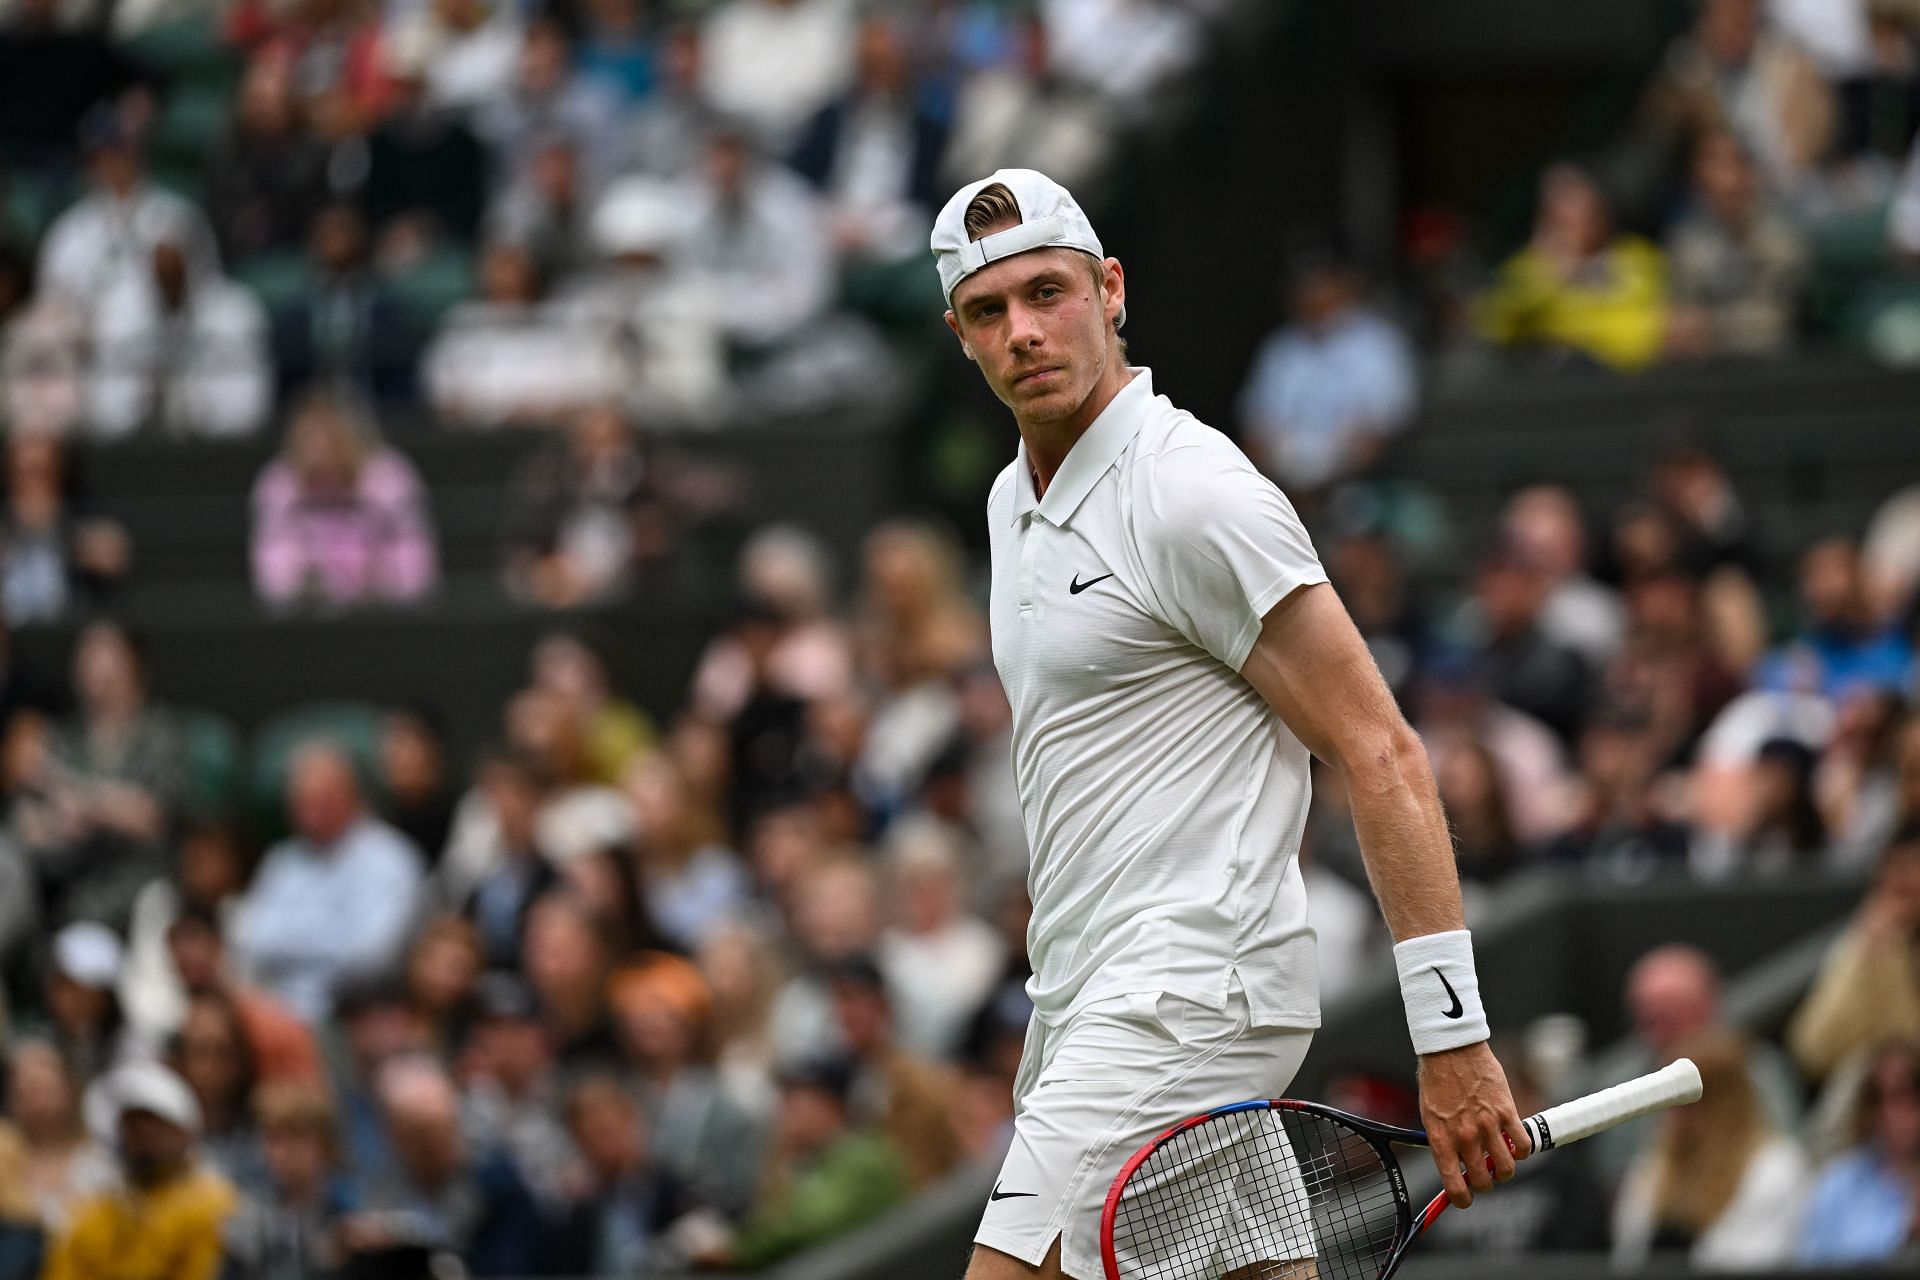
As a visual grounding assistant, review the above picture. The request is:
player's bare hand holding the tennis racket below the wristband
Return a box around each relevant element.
[1421,1040,1532,1209]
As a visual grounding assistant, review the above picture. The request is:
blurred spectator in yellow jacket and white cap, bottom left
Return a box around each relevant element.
[42,1063,234,1280]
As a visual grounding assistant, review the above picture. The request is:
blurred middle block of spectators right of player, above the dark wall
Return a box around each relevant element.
[1282,447,1920,901]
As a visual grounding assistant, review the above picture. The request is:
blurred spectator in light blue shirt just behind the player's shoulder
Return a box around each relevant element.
[1240,253,1419,495]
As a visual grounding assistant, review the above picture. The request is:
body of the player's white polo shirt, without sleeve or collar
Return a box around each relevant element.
[989,457,1306,1013]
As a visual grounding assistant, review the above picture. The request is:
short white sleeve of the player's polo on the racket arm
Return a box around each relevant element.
[1133,428,1327,672]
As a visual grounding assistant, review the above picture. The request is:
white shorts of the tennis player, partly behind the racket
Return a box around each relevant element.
[973,992,1313,1280]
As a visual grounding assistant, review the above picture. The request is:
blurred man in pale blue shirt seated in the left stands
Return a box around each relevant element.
[234,745,424,1021]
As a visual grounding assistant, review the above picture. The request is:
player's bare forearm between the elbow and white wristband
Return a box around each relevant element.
[1342,727,1467,942]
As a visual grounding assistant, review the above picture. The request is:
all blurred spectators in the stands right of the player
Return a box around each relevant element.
[1213,10,1920,1270]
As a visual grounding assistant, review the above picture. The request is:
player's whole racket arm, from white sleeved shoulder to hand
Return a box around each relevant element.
[1133,443,1526,1207]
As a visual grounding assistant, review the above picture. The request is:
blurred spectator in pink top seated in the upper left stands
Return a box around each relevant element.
[253,395,440,606]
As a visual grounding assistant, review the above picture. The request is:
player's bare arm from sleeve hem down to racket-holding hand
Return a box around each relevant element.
[1240,581,1530,1207]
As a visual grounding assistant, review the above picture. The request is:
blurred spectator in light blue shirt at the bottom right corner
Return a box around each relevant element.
[1799,1040,1920,1267]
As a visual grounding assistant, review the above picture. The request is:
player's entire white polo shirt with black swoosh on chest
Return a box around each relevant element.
[987,368,1327,1027]
